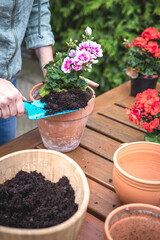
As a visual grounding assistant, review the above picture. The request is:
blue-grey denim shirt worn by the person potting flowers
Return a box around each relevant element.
[0,0,54,81]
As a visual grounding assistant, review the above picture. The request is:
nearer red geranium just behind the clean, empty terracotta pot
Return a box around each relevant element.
[126,89,160,143]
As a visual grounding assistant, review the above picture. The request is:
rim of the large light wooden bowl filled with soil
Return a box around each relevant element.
[0,149,90,236]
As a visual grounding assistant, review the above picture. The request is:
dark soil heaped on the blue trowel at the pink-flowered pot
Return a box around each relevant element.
[41,87,92,115]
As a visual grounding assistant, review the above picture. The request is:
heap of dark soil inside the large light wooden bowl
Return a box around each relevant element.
[0,171,78,229]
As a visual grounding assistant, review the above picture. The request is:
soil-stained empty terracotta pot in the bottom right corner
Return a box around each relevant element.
[105,204,160,240]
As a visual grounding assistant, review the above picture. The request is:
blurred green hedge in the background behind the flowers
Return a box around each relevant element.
[50,0,160,95]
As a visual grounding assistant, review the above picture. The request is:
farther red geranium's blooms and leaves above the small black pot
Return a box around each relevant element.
[124,27,160,79]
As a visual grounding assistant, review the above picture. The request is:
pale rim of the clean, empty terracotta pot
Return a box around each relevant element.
[113,141,160,186]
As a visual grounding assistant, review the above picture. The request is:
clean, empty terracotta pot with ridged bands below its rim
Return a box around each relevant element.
[113,142,160,206]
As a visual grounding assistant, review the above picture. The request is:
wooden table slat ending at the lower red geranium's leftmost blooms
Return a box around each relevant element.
[99,105,146,133]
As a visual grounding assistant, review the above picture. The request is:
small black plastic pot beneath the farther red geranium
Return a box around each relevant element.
[131,76,158,97]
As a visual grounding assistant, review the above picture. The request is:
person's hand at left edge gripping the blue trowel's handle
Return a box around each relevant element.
[0,78,25,119]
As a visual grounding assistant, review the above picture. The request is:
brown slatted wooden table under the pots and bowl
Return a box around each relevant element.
[0,82,160,240]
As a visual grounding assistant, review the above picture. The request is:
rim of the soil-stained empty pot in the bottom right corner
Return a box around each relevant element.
[104,203,160,240]
